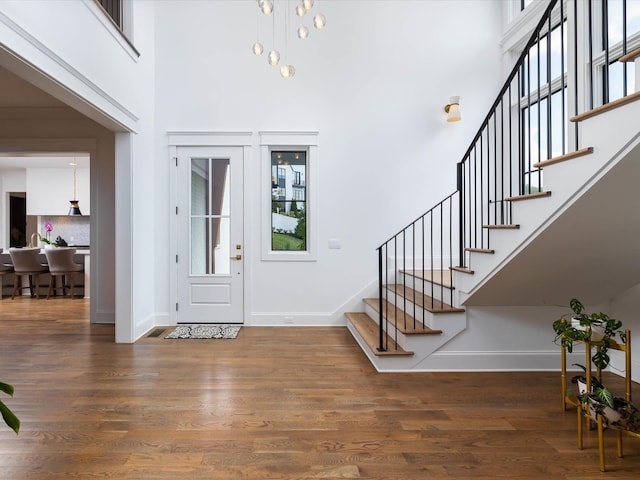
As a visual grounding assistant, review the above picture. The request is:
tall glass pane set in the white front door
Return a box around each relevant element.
[190,158,231,275]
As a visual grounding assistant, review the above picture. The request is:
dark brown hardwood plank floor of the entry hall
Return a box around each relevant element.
[0,298,640,480]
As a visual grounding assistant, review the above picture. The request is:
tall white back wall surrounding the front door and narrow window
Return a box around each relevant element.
[155,0,502,324]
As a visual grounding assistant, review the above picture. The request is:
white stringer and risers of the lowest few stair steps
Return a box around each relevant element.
[347,309,467,372]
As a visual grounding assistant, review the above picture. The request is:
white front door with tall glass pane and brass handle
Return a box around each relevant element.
[176,147,244,323]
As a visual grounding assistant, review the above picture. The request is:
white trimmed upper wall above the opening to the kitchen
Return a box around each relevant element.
[0,0,140,129]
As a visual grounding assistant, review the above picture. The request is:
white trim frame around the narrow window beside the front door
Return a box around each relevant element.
[259,131,318,262]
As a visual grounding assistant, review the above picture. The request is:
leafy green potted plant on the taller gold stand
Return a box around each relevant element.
[553,298,626,369]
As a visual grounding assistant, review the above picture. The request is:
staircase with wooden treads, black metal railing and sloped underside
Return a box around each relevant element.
[346,0,640,372]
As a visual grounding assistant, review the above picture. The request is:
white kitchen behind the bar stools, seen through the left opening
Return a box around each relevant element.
[0,153,91,298]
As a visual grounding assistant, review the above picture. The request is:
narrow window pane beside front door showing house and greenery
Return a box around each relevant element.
[271,150,308,251]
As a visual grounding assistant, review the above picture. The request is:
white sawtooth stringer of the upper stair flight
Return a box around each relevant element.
[454,102,640,305]
